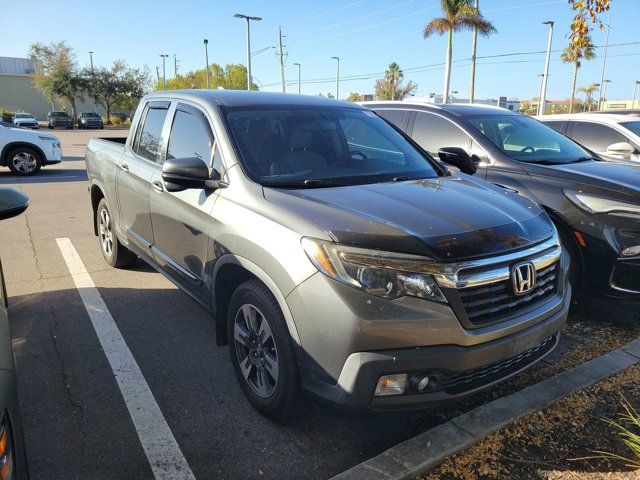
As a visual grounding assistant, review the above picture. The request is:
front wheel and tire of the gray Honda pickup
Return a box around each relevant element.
[227,280,302,422]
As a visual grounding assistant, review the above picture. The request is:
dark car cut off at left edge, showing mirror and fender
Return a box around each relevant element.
[0,187,29,480]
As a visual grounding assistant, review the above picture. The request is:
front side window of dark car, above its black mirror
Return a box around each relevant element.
[412,112,471,157]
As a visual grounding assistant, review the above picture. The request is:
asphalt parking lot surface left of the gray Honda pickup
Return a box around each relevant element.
[0,130,636,479]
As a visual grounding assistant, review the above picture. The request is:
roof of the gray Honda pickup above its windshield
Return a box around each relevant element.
[145,90,362,108]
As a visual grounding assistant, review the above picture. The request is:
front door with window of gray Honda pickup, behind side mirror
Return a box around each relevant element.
[151,102,223,303]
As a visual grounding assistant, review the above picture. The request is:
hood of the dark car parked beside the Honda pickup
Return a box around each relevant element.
[525,161,640,196]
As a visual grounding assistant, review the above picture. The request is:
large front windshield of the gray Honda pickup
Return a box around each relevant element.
[225,106,438,188]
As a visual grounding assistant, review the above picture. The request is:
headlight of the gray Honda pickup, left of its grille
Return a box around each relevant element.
[302,238,447,303]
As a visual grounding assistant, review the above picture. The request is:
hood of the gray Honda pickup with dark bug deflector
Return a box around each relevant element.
[264,175,554,261]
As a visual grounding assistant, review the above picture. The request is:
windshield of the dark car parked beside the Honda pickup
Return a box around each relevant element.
[465,115,591,165]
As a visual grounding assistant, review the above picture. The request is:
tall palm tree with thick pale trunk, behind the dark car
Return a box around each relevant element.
[423,0,497,103]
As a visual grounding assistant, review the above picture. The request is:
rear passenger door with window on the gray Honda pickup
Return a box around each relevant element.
[116,101,170,254]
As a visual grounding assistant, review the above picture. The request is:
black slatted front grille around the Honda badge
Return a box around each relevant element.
[458,261,560,326]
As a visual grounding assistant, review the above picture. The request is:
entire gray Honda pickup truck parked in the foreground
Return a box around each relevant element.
[86,90,571,419]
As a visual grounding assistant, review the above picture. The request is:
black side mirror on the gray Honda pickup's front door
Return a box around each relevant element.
[162,157,229,192]
